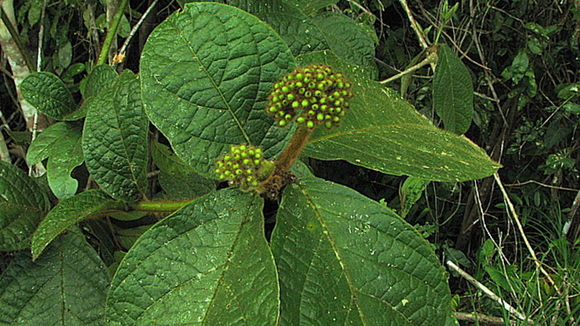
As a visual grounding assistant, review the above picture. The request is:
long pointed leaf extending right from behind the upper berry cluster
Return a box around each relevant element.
[299,51,499,181]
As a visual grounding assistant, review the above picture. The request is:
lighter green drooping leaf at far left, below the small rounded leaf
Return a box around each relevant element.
[26,122,84,199]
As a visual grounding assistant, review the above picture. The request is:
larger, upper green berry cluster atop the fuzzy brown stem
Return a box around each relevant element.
[266,65,352,128]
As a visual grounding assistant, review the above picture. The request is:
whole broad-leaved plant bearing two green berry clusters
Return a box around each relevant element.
[0,1,499,326]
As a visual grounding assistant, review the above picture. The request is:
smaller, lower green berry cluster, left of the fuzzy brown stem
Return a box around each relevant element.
[215,145,274,190]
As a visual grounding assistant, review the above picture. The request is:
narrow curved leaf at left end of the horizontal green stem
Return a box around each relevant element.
[31,190,123,259]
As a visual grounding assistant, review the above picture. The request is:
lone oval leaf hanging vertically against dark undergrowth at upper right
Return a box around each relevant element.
[433,44,473,134]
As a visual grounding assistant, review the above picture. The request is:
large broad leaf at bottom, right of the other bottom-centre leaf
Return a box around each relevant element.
[272,178,451,326]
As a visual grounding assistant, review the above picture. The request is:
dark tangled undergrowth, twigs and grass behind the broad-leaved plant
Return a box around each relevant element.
[0,0,580,325]
